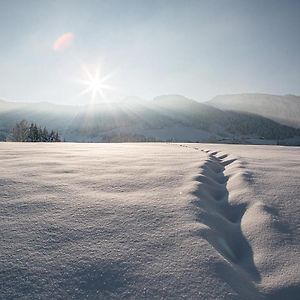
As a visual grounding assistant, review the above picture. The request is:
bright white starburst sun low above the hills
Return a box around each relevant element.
[78,65,113,104]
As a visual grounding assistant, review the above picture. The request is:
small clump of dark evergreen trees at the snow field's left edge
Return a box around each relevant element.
[7,120,61,142]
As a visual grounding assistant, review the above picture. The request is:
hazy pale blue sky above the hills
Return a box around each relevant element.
[0,0,300,104]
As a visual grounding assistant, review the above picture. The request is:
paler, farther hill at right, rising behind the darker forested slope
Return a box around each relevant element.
[206,94,300,128]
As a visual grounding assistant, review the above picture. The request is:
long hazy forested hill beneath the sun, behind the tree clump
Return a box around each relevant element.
[0,95,300,143]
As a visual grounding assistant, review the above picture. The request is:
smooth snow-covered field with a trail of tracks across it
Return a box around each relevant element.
[0,143,300,299]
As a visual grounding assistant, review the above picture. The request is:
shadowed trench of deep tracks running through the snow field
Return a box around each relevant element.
[184,146,262,299]
